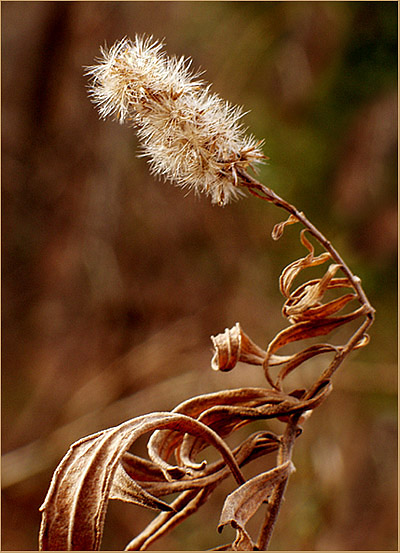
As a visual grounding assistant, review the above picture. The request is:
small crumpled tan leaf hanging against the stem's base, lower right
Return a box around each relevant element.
[218,461,294,551]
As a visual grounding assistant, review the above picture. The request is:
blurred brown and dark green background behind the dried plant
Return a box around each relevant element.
[1,2,397,551]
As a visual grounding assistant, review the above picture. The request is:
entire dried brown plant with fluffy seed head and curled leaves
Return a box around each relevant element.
[40,37,374,551]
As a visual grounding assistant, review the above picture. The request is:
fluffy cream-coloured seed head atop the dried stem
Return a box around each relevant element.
[87,36,265,205]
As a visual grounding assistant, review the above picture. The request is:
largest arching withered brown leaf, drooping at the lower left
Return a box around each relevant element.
[39,413,244,551]
